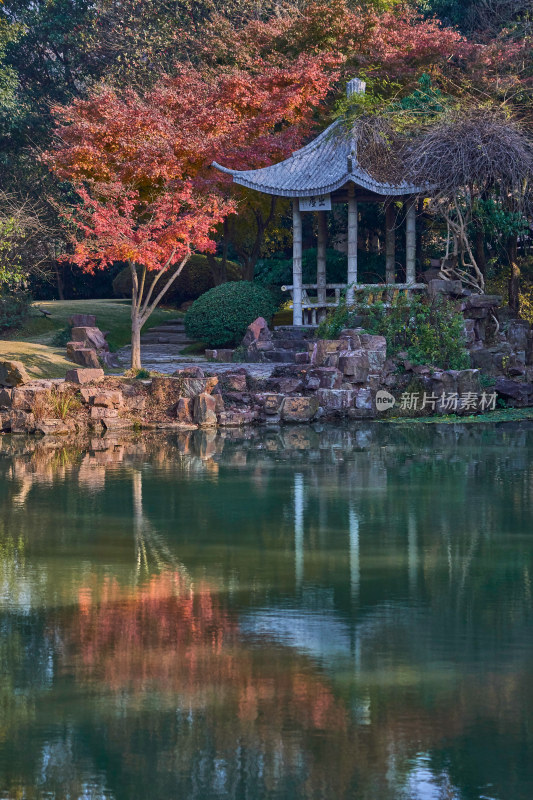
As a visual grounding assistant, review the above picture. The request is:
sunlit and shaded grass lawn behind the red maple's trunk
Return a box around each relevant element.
[0,299,179,378]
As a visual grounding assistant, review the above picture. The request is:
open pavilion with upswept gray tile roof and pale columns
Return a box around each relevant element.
[213,78,428,326]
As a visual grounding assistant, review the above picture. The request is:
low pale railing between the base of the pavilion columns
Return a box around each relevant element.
[281,283,427,325]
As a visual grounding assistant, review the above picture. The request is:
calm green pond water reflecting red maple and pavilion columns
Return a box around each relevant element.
[0,423,533,800]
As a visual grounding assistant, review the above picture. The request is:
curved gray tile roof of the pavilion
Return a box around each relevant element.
[213,120,428,197]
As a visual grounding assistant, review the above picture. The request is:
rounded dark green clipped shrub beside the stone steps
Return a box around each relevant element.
[185,281,276,347]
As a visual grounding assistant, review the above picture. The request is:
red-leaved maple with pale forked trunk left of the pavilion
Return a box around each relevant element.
[45,61,334,369]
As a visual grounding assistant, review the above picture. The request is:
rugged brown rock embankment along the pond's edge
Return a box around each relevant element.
[4,310,533,435]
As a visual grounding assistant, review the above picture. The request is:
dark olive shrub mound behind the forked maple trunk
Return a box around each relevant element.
[113,255,241,305]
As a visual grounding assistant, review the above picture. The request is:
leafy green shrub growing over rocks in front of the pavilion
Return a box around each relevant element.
[366,295,470,369]
